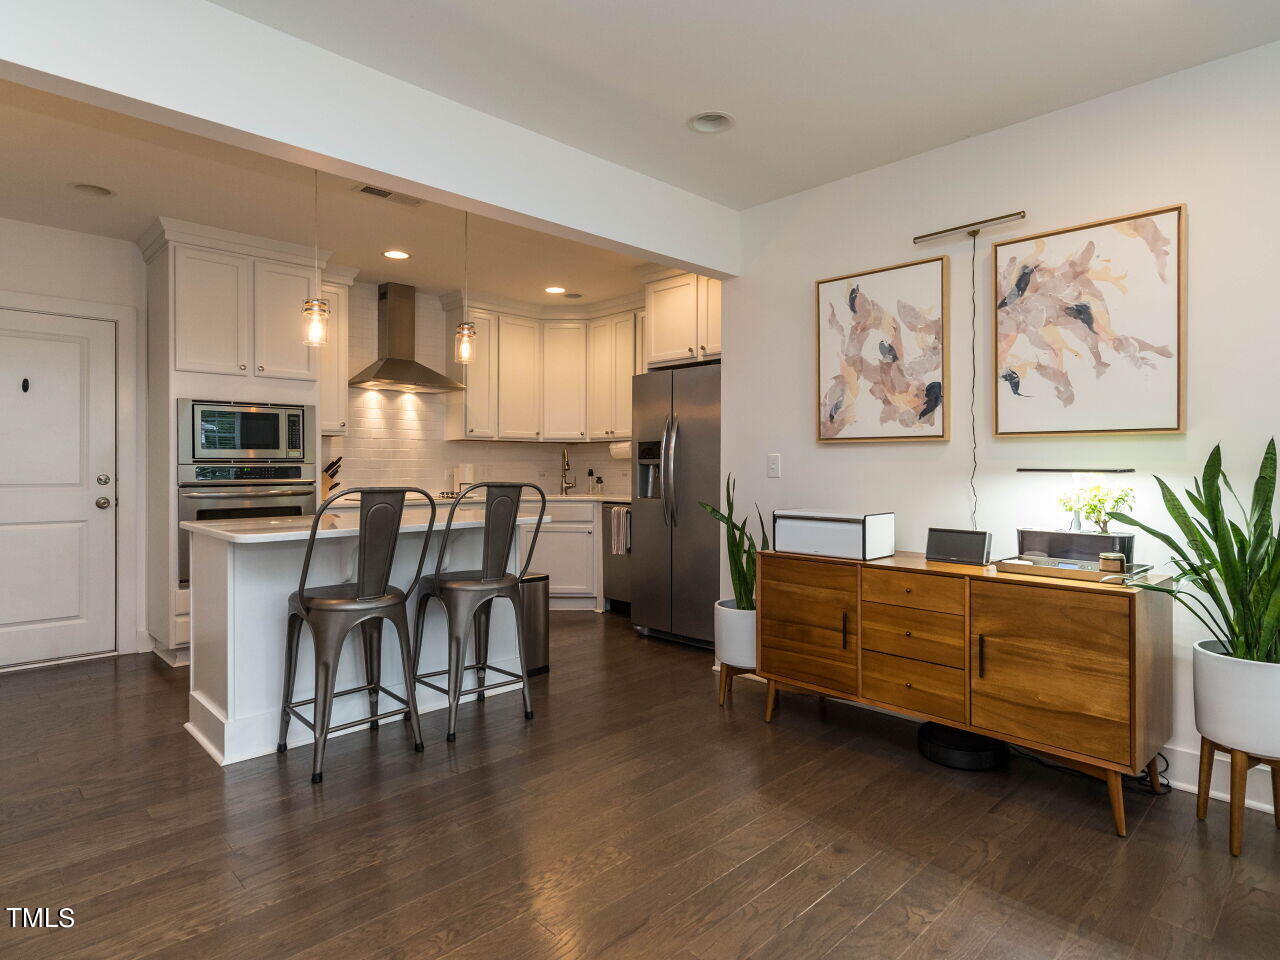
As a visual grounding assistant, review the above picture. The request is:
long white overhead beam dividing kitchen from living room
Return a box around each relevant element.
[0,0,739,273]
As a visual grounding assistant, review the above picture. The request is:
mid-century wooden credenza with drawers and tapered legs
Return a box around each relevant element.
[756,552,1172,836]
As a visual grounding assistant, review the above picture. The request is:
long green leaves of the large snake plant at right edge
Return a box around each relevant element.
[1111,439,1280,663]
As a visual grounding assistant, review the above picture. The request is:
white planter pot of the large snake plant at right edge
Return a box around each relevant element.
[1192,640,1280,756]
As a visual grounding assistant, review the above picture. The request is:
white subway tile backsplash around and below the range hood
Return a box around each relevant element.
[321,283,631,497]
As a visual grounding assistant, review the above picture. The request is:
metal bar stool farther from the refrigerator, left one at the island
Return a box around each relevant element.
[275,486,435,783]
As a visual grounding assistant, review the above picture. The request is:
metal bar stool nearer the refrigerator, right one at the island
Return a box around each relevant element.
[413,483,547,742]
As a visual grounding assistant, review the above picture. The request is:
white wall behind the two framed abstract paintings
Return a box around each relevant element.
[723,44,1280,806]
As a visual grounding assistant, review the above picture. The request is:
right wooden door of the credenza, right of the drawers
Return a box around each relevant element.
[969,580,1132,763]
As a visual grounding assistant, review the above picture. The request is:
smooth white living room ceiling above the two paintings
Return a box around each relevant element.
[204,0,1280,209]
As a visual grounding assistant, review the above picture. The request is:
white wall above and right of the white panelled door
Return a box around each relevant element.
[0,219,151,653]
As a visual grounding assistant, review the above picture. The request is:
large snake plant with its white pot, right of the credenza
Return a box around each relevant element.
[1111,439,1280,756]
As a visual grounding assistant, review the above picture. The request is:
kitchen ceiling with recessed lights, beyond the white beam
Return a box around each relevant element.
[0,81,657,307]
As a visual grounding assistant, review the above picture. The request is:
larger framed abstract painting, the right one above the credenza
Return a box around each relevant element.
[992,206,1187,436]
